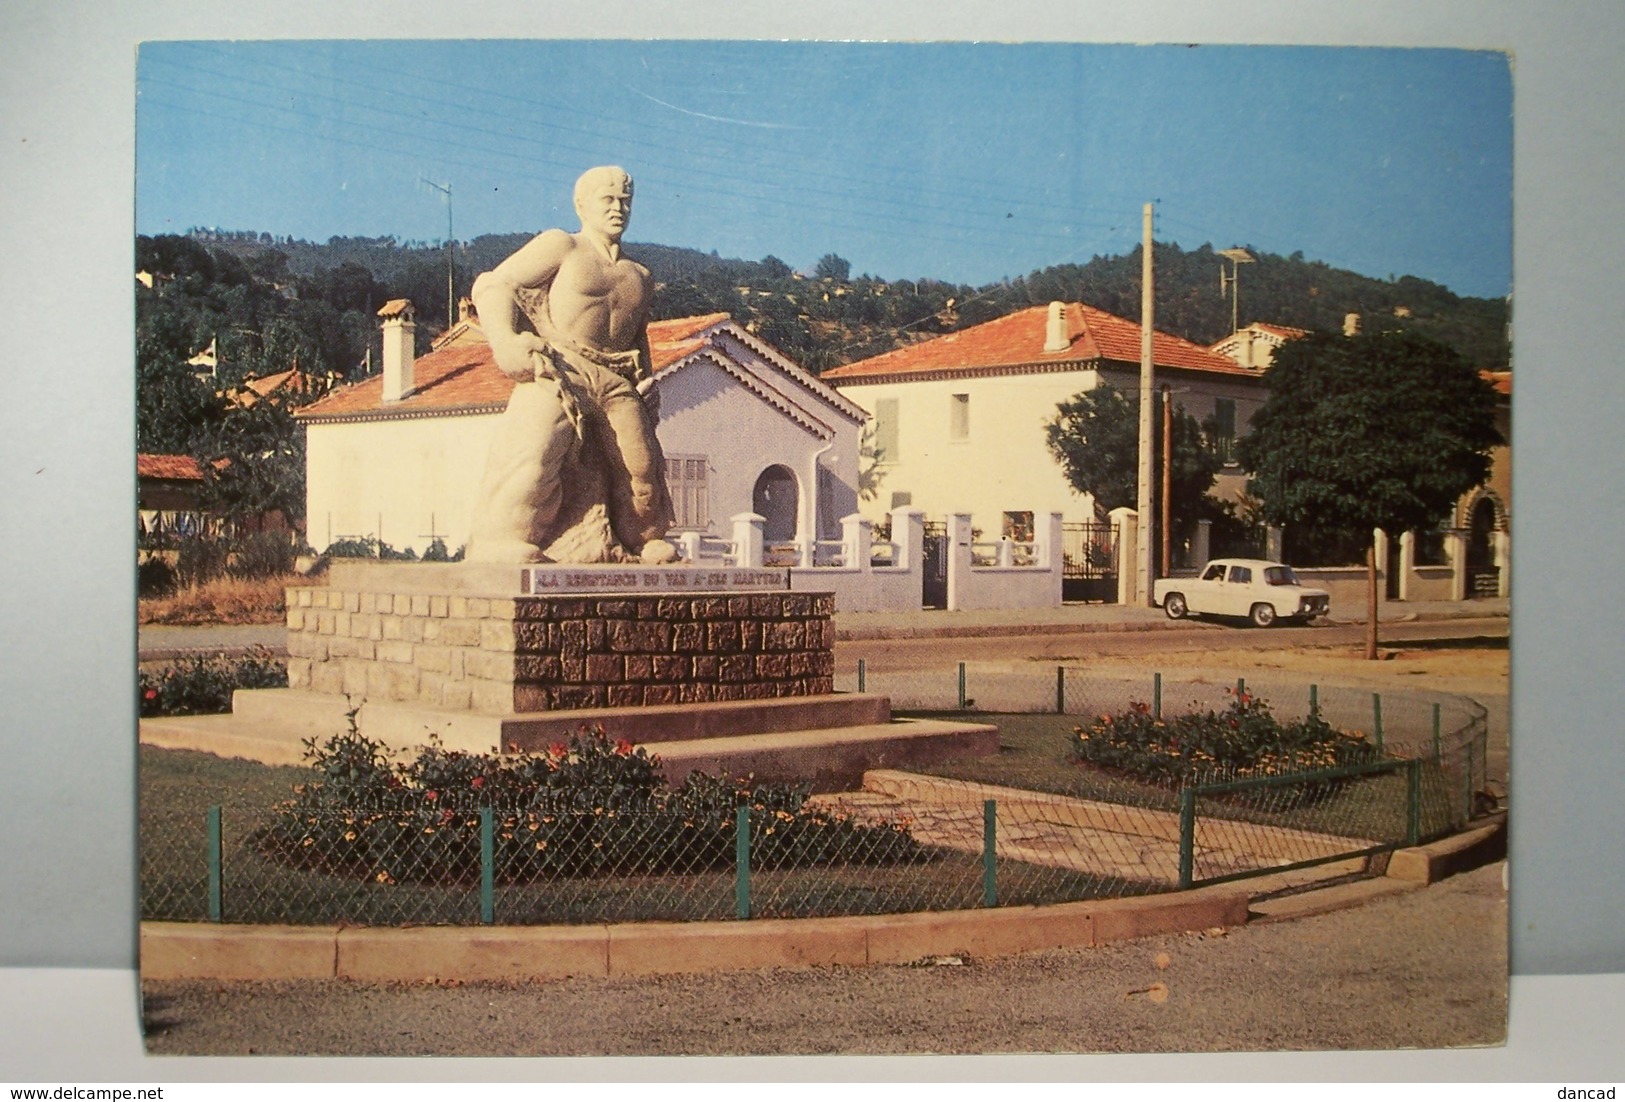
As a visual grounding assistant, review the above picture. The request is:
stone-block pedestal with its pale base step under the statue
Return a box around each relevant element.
[141,562,998,790]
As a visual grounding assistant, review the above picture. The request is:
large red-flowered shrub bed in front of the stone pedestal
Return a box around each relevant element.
[257,724,921,884]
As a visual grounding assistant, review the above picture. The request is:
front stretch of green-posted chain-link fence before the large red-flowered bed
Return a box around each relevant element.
[141,796,1172,925]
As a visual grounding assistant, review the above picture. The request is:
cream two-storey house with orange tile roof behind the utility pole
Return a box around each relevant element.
[822,302,1264,538]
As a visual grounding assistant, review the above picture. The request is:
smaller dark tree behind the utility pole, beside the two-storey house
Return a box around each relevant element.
[1045,385,1220,530]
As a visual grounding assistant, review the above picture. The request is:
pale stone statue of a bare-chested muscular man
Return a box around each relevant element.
[466,167,678,562]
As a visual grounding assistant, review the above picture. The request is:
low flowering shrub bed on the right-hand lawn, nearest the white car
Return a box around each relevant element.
[1073,689,1378,785]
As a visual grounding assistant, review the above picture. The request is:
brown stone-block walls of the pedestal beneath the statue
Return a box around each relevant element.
[288,588,835,714]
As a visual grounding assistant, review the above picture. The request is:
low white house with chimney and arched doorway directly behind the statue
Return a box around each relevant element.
[296,299,866,553]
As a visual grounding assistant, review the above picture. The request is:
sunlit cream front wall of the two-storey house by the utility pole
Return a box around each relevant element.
[842,371,1095,540]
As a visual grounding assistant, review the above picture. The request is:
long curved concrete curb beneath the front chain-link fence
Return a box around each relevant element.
[141,886,1248,983]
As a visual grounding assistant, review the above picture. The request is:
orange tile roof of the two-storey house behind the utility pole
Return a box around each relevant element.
[819,302,1258,384]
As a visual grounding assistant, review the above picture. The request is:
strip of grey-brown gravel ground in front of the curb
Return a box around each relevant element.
[143,863,1506,1056]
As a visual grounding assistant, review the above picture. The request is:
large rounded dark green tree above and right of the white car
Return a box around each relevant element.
[1237,333,1503,658]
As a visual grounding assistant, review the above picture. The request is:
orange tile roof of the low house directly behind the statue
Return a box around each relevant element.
[294,314,728,421]
